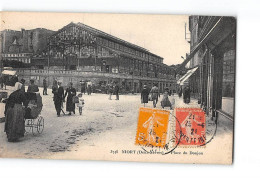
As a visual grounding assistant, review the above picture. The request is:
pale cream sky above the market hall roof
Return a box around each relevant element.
[1,12,190,65]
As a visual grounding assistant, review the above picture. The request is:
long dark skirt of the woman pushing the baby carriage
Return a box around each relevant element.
[5,104,25,142]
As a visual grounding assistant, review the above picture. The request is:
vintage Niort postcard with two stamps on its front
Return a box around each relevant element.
[0,12,236,164]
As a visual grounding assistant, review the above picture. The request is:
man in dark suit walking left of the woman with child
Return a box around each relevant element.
[52,81,64,117]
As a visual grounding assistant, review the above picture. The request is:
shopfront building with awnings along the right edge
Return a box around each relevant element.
[179,16,236,120]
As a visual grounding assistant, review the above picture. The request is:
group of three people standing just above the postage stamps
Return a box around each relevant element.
[141,84,174,109]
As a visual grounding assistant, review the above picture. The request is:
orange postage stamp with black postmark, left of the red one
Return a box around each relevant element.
[135,108,170,147]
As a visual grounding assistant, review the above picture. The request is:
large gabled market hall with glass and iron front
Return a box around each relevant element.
[3,23,176,92]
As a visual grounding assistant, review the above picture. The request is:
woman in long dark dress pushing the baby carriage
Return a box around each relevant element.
[5,82,27,142]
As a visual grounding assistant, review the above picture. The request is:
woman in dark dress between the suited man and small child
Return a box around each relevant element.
[64,82,76,115]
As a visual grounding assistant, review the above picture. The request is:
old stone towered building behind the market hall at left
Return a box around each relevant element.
[1,28,53,68]
